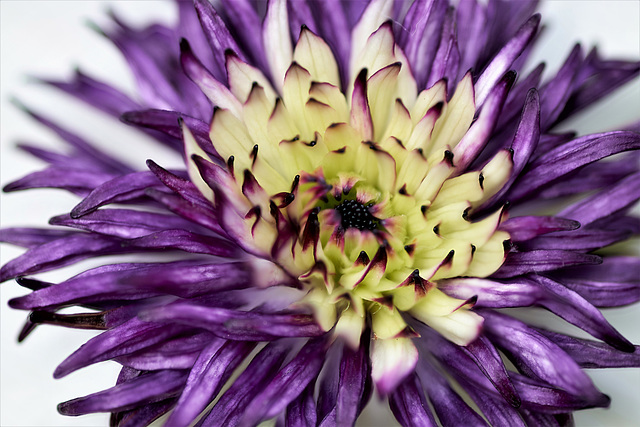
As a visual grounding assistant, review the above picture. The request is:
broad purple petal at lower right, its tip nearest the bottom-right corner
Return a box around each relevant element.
[481,311,604,402]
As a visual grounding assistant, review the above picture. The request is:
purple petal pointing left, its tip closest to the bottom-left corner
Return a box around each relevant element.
[58,370,187,416]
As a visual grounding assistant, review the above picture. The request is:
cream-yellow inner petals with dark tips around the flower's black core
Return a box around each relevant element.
[187,26,512,346]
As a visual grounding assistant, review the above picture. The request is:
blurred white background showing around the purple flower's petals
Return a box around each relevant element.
[0,0,640,426]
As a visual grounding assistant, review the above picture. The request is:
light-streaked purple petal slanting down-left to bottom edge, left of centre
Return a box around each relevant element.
[166,340,255,425]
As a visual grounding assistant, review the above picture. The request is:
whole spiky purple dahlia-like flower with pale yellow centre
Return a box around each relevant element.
[0,0,640,426]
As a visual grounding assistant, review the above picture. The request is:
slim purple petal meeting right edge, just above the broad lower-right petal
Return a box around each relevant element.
[536,329,640,369]
